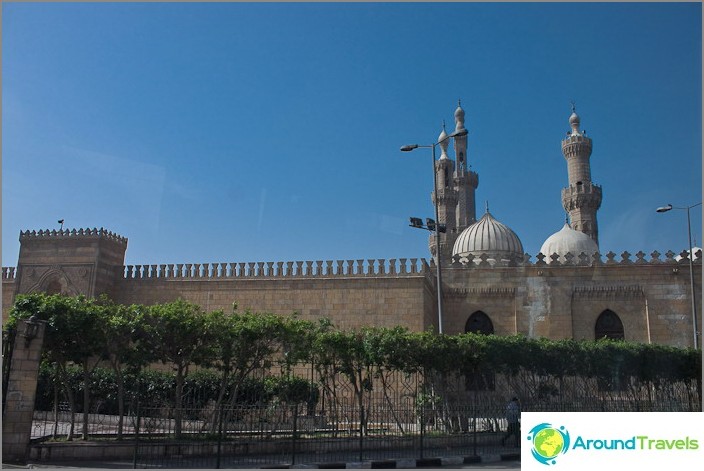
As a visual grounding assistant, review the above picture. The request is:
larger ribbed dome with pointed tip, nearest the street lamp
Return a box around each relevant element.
[452,210,523,260]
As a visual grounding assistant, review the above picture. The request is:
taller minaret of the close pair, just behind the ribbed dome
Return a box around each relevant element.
[454,101,479,233]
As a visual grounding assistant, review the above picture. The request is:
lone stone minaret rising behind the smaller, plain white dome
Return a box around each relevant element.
[562,103,601,246]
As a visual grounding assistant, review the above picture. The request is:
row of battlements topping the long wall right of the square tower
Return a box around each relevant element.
[124,258,431,279]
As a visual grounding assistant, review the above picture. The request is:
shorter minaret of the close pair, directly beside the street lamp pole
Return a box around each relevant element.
[428,123,457,264]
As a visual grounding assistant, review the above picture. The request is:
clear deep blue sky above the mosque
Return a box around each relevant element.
[2,2,702,266]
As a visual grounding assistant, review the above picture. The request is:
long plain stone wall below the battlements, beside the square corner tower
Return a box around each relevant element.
[115,274,434,330]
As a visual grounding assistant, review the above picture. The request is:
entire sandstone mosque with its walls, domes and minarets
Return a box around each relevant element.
[2,106,702,347]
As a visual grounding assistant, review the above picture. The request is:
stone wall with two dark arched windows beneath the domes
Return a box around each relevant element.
[443,261,702,346]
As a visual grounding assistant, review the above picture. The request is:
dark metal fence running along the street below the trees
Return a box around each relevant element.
[27,367,701,469]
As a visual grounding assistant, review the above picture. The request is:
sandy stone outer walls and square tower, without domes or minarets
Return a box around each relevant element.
[3,240,702,346]
